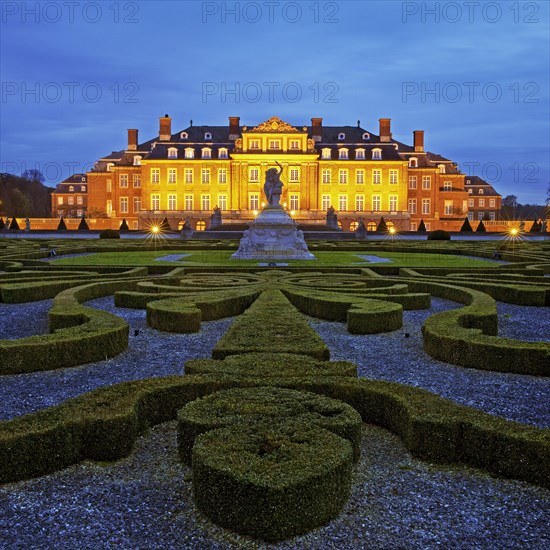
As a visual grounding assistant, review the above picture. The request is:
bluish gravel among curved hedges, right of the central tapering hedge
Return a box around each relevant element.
[309,298,550,427]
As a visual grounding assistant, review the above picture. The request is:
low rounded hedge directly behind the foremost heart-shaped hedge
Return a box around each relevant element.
[178,387,362,465]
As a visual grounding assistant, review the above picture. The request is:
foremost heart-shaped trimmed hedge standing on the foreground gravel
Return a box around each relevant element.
[193,423,352,542]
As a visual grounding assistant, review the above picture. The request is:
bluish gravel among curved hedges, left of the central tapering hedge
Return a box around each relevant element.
[0,296,233,419]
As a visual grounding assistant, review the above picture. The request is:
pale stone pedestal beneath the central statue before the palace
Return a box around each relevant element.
[231,205,315,261]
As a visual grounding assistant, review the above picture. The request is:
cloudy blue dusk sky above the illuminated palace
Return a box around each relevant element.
[0,0,550,204]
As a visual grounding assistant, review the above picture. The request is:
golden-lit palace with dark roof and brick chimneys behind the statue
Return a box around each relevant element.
[86,115,500,231]
